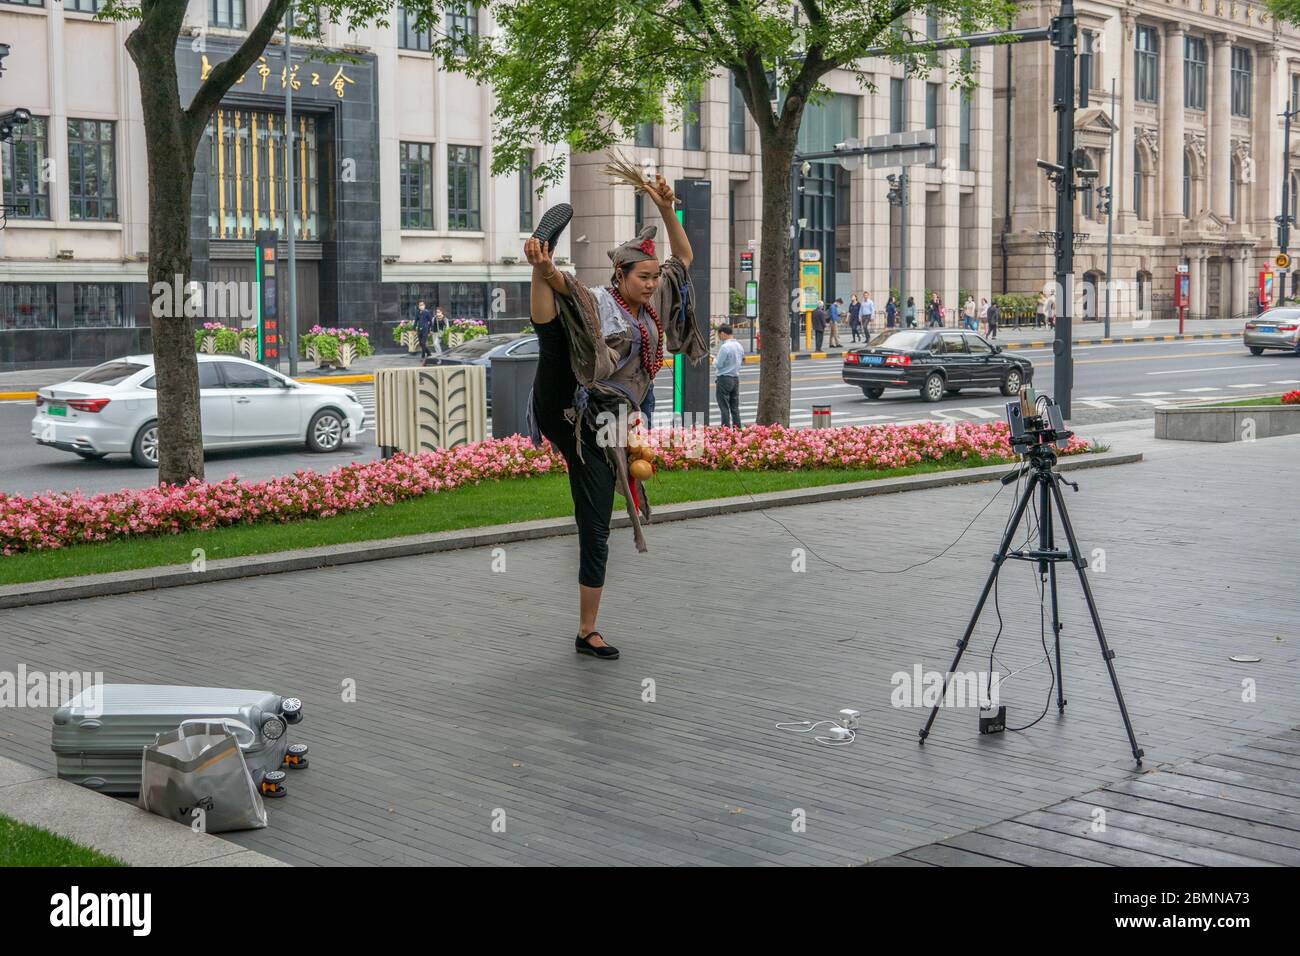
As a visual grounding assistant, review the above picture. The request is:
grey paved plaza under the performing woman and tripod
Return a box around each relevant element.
[0,429,1300,865]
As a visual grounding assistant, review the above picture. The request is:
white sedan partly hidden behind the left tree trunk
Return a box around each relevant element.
[31,354,365,468]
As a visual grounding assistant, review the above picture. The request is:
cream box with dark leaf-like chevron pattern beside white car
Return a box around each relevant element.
[374,365,488,458]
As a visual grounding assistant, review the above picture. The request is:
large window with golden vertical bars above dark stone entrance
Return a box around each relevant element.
[207,107,320,239]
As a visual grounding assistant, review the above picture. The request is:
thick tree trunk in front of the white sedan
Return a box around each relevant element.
[126,12,203,484]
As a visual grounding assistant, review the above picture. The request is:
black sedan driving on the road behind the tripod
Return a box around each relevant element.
[842,329,1034,402]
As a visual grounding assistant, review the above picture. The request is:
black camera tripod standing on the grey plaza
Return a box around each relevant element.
[920,432,1143,766]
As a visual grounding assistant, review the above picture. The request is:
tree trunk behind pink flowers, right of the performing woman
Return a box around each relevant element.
[754,120,798,425]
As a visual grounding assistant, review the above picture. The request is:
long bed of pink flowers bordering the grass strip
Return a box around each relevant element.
[0,423,1088,554]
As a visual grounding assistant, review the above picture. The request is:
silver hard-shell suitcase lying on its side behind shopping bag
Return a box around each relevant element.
[49,684,307,796]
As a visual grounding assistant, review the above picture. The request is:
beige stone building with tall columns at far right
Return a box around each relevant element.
[993,0,1300,319]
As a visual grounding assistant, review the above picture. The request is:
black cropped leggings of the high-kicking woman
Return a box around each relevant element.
[533,319,614,588]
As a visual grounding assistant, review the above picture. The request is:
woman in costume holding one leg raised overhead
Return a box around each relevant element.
[524,176,709,661]
